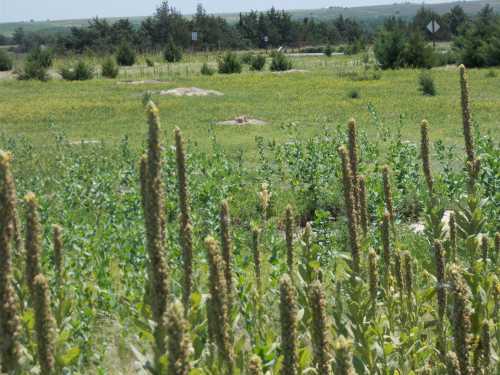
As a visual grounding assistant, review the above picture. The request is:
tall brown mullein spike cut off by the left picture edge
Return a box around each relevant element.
[0,150,21,374]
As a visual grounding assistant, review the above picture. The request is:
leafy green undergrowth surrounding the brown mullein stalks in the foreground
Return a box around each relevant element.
[0,81,499,374]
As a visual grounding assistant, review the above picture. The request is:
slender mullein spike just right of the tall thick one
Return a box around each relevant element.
[175,128,193,314]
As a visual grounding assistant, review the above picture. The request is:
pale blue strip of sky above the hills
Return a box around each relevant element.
[0,0,460,22]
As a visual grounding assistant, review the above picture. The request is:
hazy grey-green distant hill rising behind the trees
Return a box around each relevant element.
[0,0,500,35]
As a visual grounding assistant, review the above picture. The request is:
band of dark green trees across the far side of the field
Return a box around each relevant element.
[0,1,500,68]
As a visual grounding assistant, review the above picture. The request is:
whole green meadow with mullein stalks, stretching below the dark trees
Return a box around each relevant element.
[0,55,500,375]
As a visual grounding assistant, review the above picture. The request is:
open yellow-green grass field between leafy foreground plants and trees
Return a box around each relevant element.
[0,56,500,163]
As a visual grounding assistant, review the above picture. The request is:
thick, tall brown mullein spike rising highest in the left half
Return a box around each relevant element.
[141,102,168,372]
